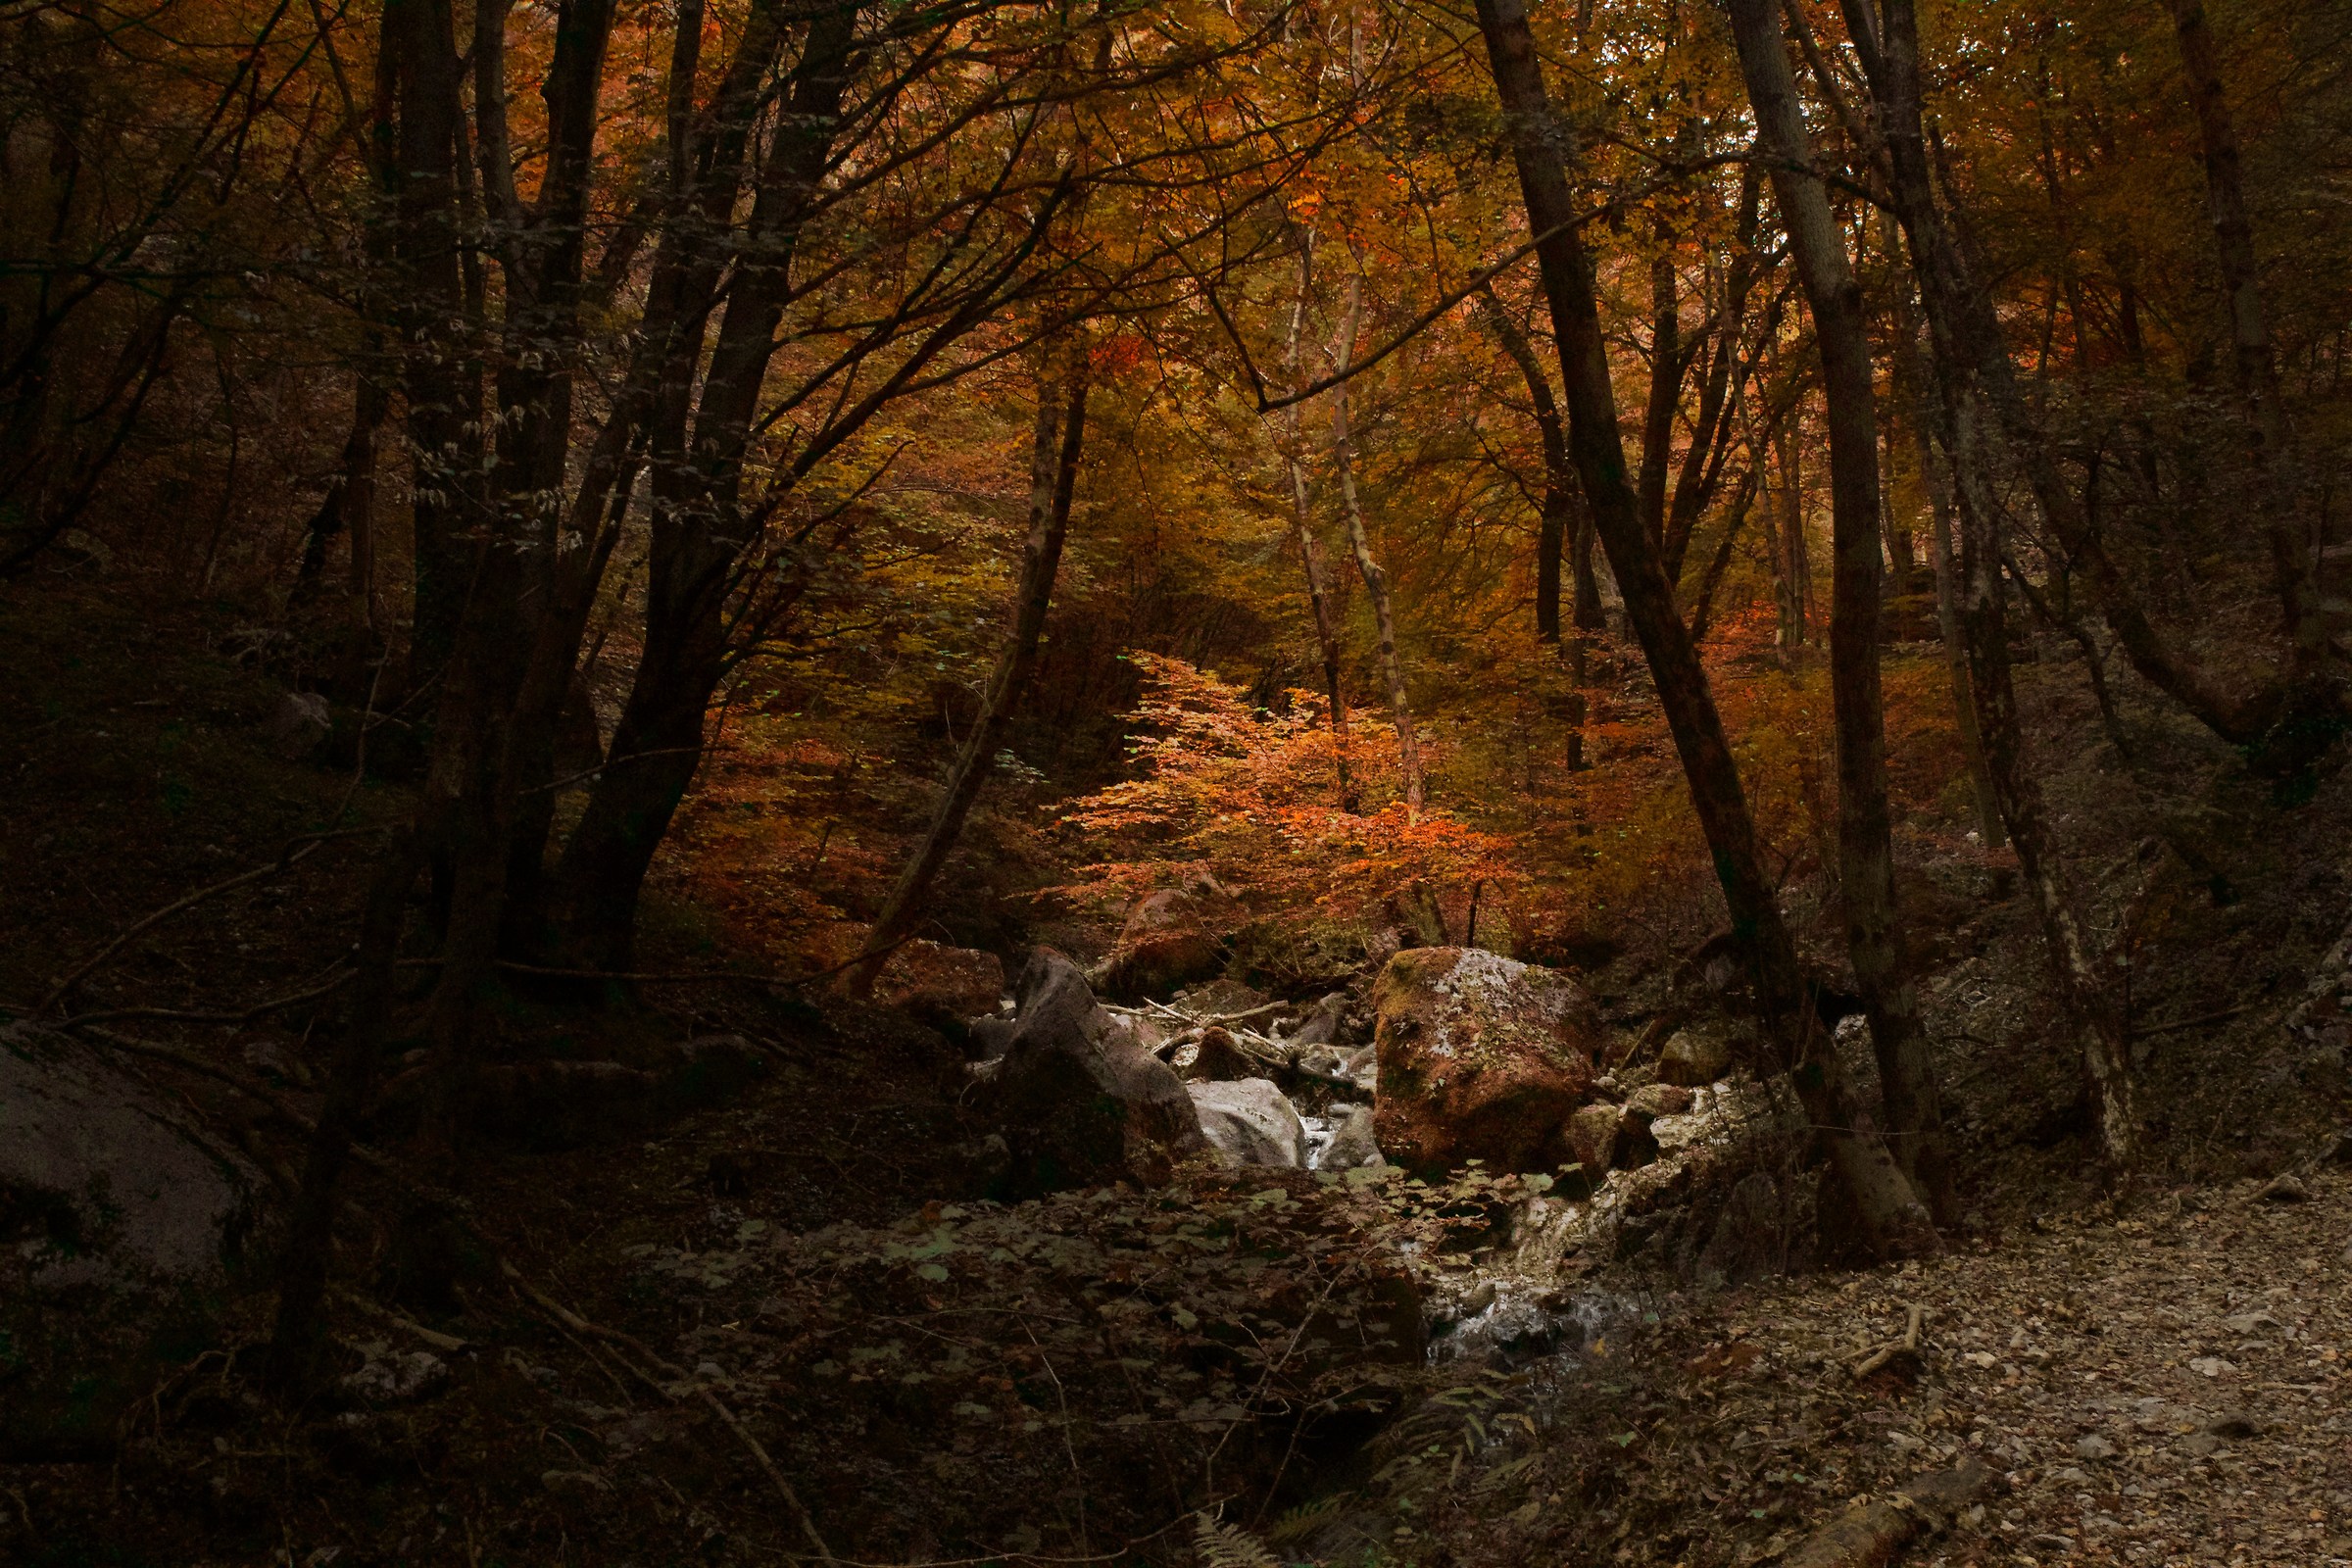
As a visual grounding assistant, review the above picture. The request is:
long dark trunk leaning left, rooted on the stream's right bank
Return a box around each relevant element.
[1477,0,1938,1255]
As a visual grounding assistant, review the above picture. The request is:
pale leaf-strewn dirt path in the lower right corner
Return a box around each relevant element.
[1637,1168,2352,1568]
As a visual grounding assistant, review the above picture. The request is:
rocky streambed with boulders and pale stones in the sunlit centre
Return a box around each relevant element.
[969,948,1801,1366]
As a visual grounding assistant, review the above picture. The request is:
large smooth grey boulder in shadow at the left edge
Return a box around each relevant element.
[0,1025,261,1462]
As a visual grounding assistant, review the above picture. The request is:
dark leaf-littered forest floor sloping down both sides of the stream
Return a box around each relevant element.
[0,590,2352,1568]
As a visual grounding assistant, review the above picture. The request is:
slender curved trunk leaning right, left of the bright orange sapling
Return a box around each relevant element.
[845,362,1087,1002]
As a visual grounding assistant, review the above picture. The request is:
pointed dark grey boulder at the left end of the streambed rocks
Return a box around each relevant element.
[971,948,1206,1197]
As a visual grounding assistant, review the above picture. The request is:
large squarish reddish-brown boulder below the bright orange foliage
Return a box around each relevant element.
[1371,948,1606,1173]
